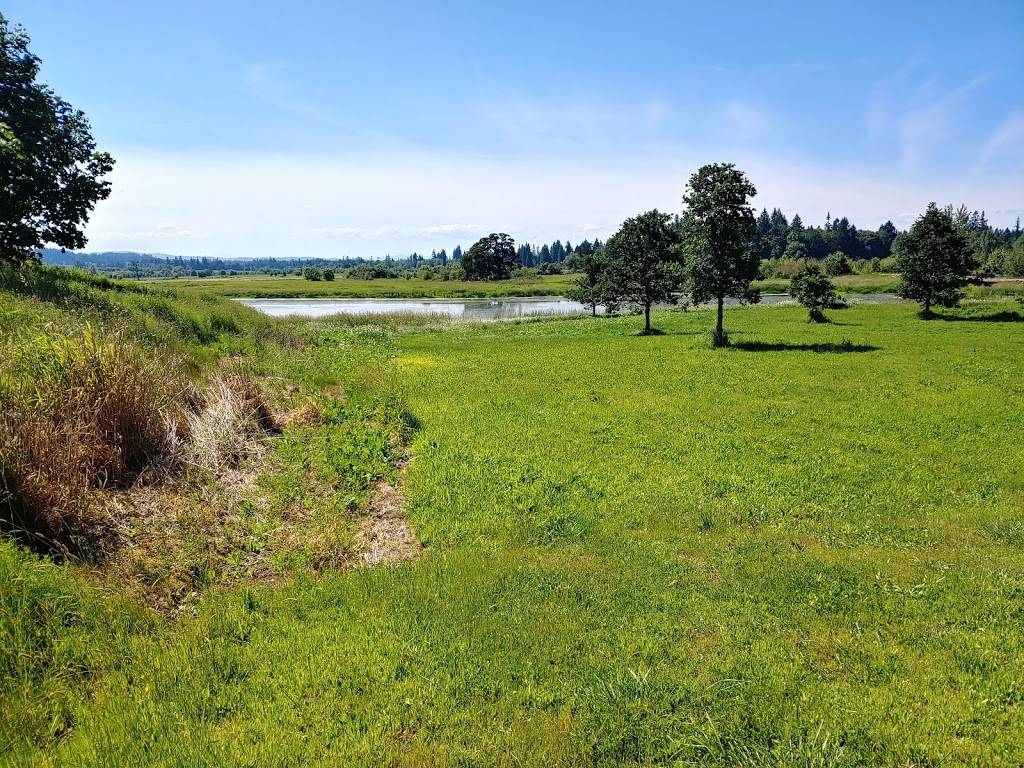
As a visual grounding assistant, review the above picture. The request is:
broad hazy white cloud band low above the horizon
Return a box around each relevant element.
[88,147,1024,257]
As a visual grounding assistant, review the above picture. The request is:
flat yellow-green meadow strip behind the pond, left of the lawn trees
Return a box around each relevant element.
[141,274,575,299]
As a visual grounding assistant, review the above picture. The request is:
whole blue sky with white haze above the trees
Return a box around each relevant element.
[4,0,1024,256]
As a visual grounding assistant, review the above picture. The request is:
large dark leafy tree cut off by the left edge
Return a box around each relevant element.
[0,13,114,263]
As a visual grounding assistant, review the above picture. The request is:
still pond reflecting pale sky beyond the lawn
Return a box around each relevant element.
[240,294,900,321]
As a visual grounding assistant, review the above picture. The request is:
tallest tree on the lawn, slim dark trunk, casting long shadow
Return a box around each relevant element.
[683,163,761,345]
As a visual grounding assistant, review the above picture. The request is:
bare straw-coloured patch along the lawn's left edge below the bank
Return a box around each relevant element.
[355,459,423,567]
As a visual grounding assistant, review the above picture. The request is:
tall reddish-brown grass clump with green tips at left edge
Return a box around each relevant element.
[0,325,187,555]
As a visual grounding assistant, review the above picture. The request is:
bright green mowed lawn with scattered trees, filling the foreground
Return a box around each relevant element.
[22,303,1024,766]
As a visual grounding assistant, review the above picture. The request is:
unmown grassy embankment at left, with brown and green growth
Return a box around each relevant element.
[0,268,415,755]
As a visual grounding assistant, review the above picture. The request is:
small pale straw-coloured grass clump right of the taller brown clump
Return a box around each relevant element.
[184,372,278,474]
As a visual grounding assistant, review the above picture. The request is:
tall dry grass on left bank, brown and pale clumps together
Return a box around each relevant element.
[0,326,276,557]
